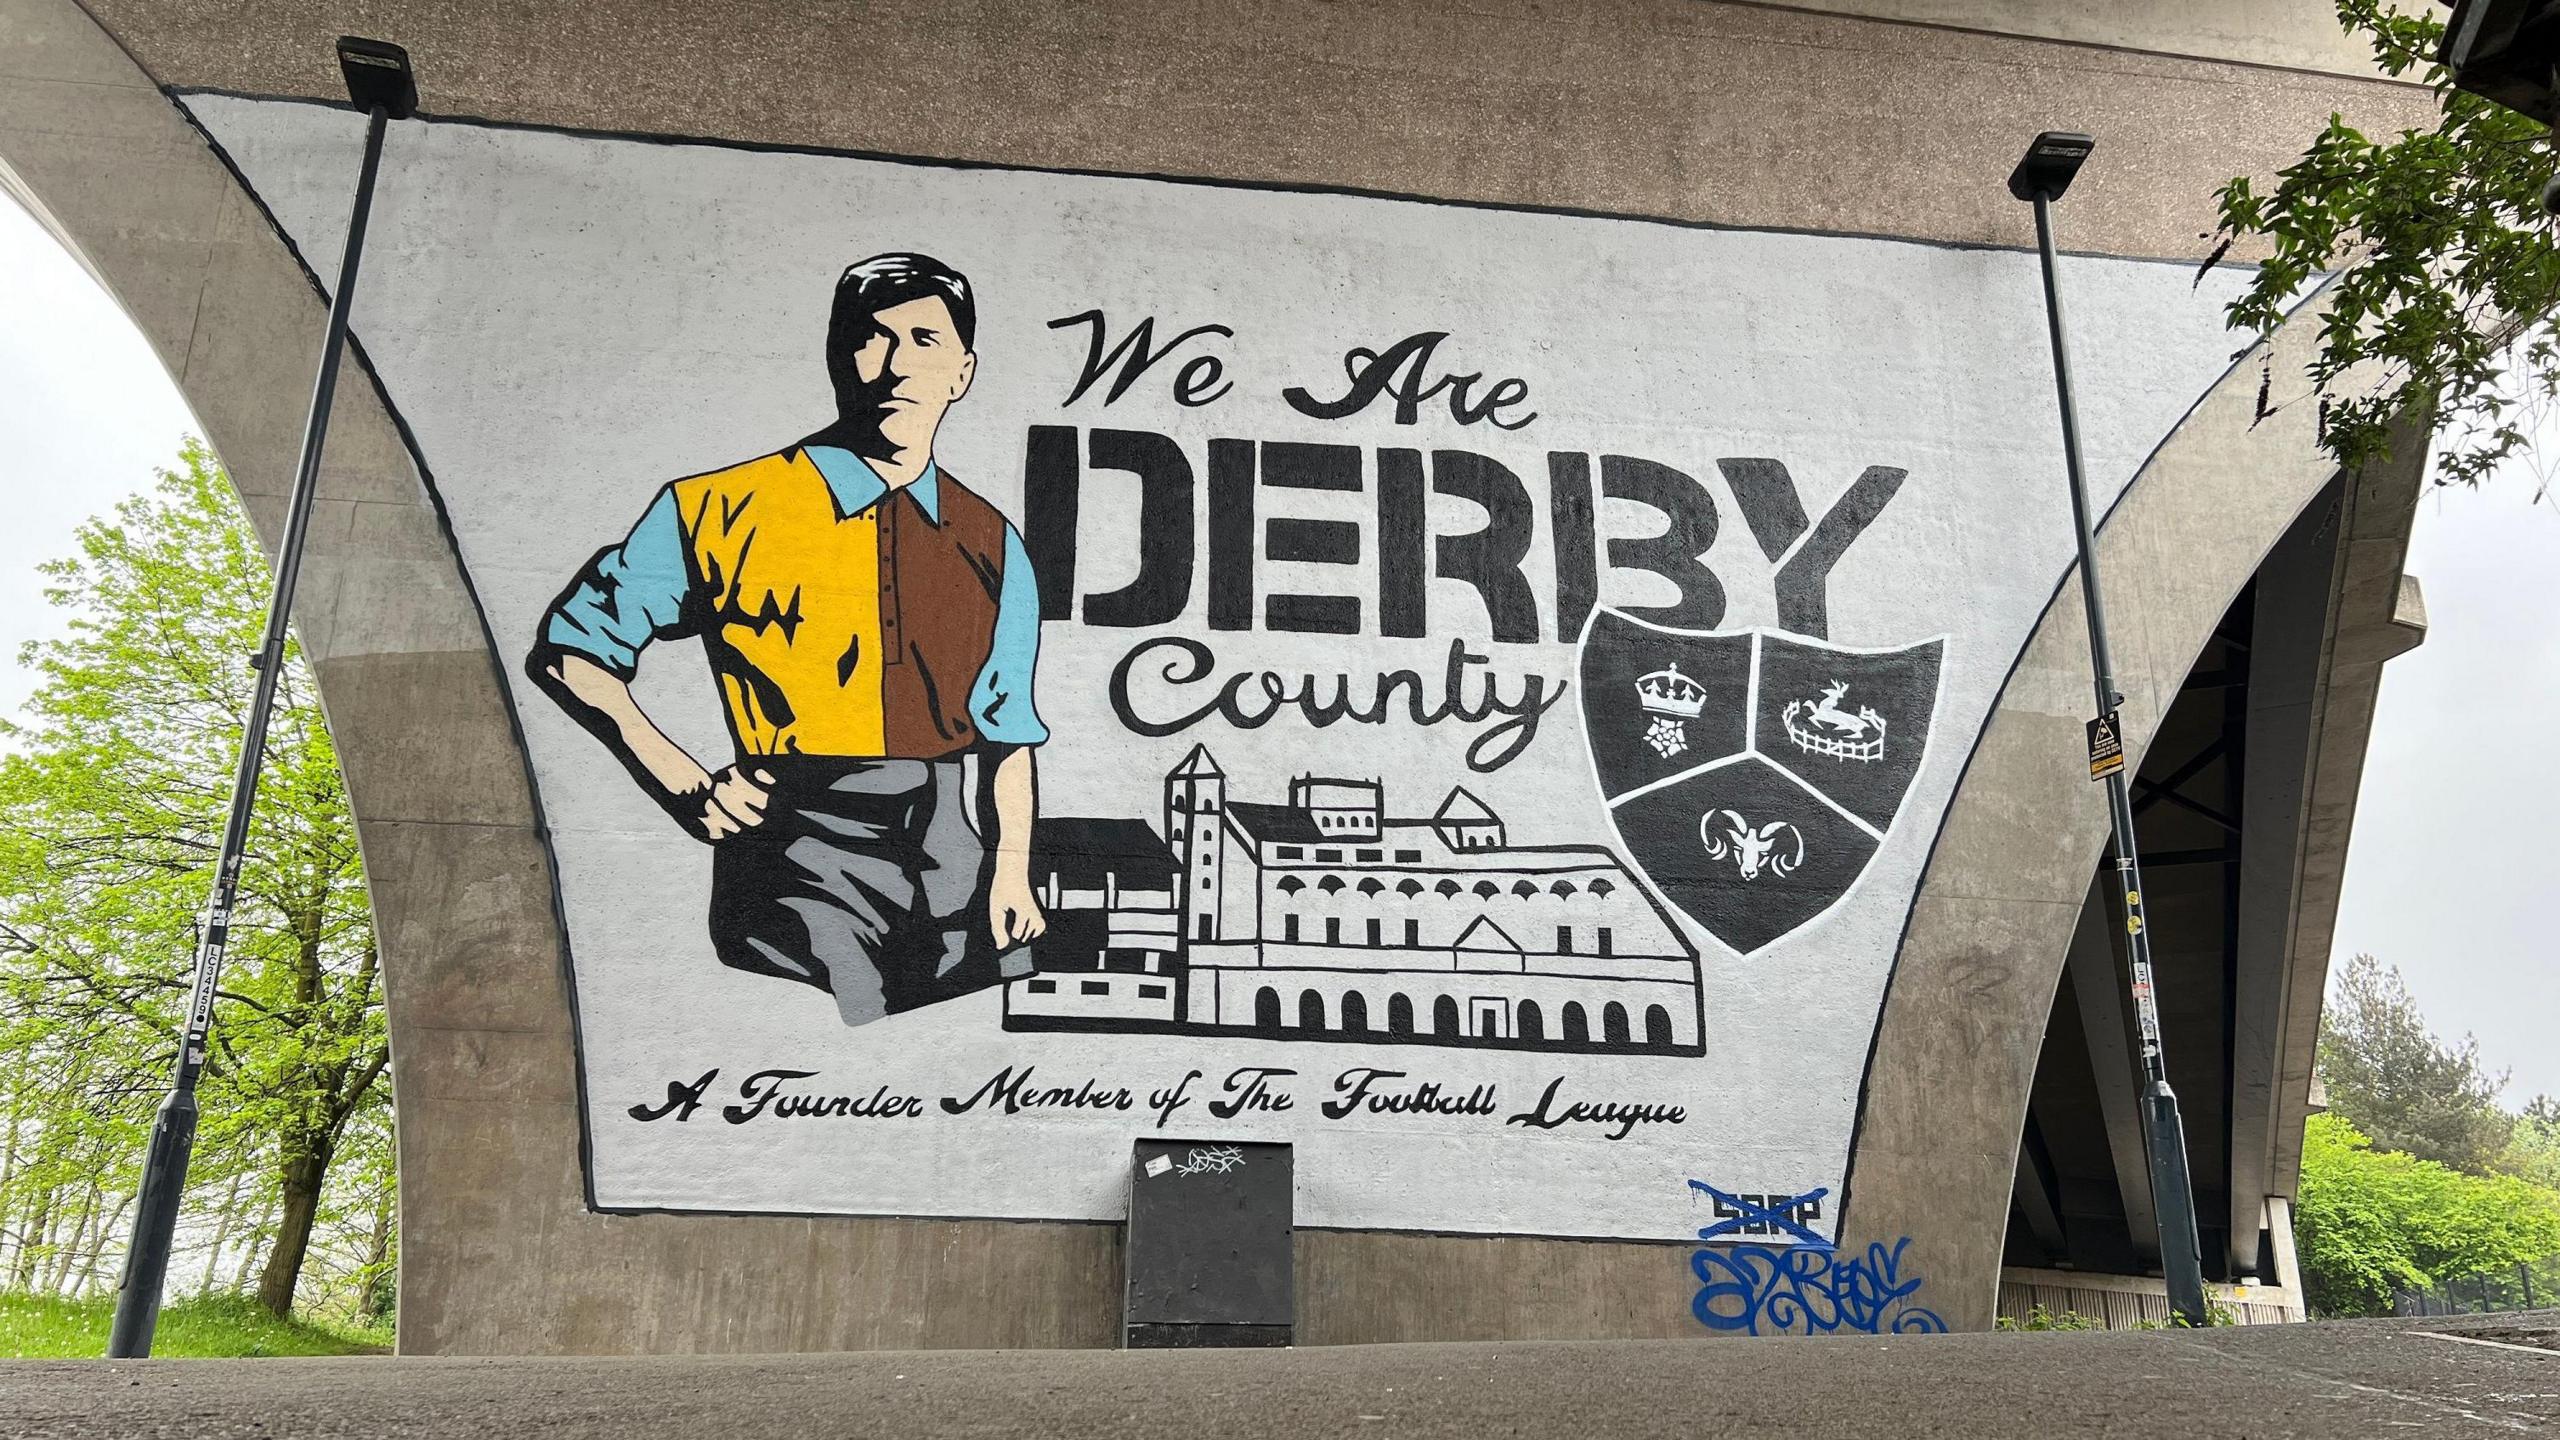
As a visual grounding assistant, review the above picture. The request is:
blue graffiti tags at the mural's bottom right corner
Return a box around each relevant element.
[1690,1181,1946,1335]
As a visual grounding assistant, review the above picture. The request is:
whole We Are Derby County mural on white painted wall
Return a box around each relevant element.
[187,95,2235,1240]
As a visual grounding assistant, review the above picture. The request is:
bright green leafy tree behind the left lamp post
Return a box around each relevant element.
[0,443,392,1314]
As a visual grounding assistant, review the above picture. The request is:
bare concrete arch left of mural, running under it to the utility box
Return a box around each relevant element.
[0,0,1119,1353]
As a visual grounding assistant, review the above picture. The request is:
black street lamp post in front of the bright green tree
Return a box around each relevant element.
[108,36,417,1361]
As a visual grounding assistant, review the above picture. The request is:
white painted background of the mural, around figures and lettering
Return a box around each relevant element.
[187,97,2240,1240]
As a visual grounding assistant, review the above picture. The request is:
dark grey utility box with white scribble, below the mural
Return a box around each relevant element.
[1121,1140,1298,1350]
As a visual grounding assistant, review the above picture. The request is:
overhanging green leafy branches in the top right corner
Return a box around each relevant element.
[2207,0,2560,484]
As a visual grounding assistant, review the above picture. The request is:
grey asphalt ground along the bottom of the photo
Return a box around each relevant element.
[0,1312,2560,1440]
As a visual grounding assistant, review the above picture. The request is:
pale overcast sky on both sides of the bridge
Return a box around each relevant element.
[0,197,2560,1086]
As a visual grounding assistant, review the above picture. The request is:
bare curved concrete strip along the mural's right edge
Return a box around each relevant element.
[1841,278,2427,1330]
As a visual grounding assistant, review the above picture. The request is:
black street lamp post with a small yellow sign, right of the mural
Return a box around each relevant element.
[2010,131,2207,1325]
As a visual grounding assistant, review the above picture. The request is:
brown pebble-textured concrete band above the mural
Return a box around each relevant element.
[74,0,2432,259]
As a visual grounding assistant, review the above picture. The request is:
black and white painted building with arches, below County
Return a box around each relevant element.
[1004,746,1702,1056]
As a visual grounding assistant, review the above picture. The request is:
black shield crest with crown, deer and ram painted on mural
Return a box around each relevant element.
[1582,610,1946,953]
